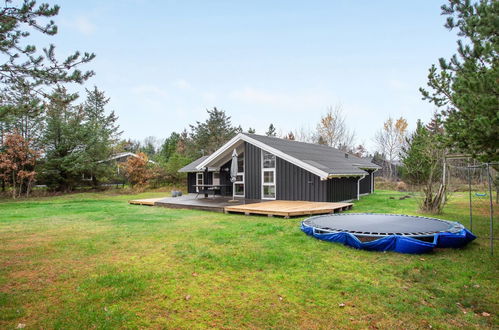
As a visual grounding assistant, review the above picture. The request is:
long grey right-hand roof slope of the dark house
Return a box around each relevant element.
[243,133,381,176]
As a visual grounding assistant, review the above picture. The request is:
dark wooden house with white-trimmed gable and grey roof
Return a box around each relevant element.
[179,133,381,202]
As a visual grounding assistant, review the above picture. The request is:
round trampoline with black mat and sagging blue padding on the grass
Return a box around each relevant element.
[301,213,476,253]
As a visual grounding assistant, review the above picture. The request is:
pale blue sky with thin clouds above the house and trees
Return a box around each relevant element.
[29,0,457,151]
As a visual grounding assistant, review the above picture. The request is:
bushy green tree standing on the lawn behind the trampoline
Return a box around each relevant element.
[401,120,446,213]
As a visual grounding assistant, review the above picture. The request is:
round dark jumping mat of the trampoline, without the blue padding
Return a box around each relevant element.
[305,213,461,236]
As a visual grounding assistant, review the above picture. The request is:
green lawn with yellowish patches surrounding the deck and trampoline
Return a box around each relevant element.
[0,191,499,329]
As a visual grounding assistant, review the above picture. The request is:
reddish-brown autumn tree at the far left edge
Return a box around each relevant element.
[0,133,40,198]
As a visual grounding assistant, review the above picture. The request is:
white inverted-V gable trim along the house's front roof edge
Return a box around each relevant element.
[196,133,329,180]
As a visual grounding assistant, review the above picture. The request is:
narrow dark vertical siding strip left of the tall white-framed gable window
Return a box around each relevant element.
[244,142,262,199]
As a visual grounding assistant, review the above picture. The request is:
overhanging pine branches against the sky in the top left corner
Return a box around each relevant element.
[0,0,95,99]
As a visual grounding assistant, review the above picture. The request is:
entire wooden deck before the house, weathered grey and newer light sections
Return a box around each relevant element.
[129,194,353,218]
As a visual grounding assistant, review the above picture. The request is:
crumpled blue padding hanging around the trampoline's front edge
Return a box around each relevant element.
[301,222,476,254]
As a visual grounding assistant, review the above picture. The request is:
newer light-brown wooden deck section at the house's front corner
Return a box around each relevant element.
[225,201,353,218]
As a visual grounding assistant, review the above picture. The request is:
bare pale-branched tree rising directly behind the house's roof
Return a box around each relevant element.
[317,105,355,151]
